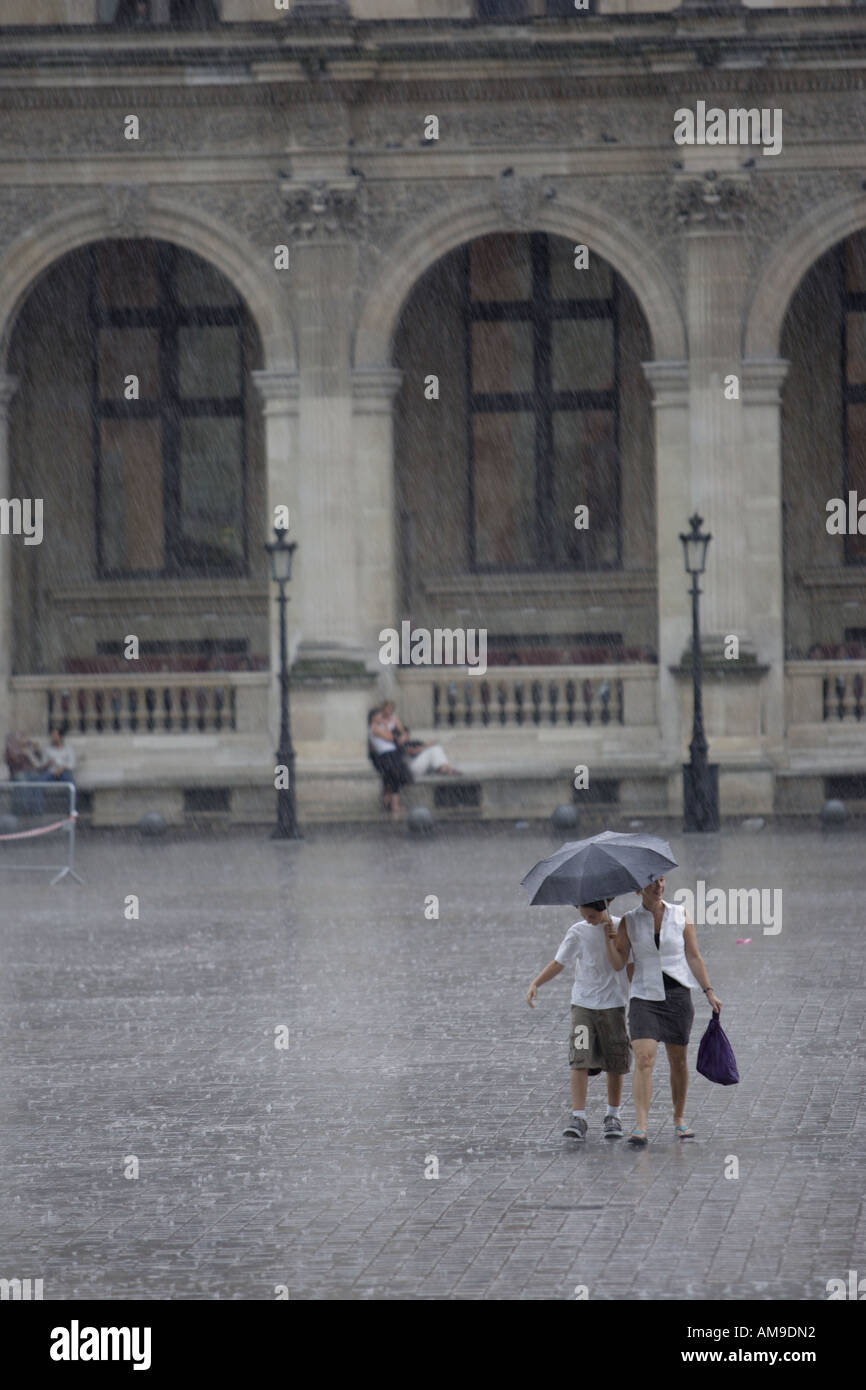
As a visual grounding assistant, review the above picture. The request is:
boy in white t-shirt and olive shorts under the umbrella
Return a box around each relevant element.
[527,898,632,1141]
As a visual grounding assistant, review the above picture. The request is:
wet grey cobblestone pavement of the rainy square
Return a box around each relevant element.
[0,826,866,1300]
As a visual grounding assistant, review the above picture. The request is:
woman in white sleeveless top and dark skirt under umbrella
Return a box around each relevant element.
[609,877,721,1148]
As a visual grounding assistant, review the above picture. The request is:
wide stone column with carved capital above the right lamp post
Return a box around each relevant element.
[676,175,753,656]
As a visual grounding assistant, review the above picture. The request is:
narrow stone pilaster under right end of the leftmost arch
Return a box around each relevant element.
[252,370,301,746]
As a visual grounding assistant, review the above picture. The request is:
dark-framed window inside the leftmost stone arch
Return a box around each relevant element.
[89,240,247,578]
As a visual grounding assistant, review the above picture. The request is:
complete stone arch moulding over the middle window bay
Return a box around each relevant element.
[353,200,687,368]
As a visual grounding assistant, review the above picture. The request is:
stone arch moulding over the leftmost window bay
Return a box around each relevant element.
[0,189,297,371]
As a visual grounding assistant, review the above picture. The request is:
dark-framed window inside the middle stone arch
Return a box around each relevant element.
[463,232,620,570]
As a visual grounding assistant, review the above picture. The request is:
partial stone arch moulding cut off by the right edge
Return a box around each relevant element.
[744,193,866,359]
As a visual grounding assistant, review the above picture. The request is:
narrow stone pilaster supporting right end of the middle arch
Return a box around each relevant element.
[644,361,691,772]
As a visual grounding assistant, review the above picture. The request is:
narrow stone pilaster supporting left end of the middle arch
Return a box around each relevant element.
[352,367,403,659]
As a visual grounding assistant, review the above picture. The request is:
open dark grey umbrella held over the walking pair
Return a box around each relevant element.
[520,830,677,906]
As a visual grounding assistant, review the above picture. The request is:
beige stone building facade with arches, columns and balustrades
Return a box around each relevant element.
[0,0,866,823]
